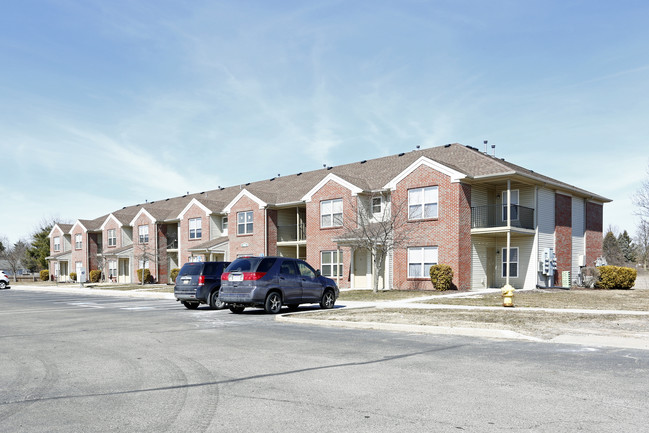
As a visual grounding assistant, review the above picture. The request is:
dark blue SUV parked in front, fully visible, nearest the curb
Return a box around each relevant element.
[220,257,340,314]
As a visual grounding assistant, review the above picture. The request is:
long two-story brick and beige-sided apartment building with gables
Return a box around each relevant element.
[49,144,610,290]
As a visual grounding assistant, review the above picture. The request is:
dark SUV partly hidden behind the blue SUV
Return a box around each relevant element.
[174,262,230,310]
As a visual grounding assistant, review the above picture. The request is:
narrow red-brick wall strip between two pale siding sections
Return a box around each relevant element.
[554,194,572,286]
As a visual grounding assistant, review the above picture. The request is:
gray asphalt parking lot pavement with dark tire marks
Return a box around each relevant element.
[0,290,649,432]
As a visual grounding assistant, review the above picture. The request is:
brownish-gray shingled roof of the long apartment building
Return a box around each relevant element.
[63,143,610,230]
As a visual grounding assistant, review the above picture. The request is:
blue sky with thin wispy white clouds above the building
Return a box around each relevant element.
[0,0,649,242]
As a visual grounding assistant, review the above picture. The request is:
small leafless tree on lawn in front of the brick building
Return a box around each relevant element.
[338,192,408,293]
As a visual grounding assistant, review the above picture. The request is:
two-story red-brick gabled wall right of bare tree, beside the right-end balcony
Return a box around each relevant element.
[392,166,471,290]
